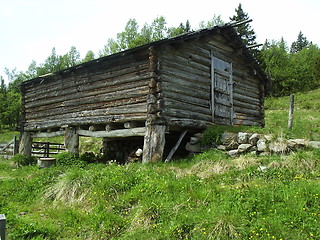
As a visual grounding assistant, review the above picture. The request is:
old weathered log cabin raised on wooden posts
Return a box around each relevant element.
[20,24,266,162]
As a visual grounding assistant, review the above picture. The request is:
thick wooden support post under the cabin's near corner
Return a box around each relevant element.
[142,124,166,163]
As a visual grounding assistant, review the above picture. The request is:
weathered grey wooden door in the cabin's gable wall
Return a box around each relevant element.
[211,56,233,125]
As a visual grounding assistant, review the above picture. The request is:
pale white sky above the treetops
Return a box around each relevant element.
[0,0,320,84]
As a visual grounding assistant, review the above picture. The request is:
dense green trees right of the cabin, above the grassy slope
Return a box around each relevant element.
[259,39,320,96]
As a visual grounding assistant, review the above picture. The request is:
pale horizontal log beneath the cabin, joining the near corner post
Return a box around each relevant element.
[77,127,146,138]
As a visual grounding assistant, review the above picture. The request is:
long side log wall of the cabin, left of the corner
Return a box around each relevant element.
[23,51,150,131]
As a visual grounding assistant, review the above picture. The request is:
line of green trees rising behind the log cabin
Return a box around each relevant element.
[0,4,320,129]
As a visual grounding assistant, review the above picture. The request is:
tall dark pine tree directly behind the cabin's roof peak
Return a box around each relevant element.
[230,3,257,46]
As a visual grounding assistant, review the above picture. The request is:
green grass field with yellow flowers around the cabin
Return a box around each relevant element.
[0,89,320,240]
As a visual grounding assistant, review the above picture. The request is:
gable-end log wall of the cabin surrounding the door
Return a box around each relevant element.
[158,30,264,127]
